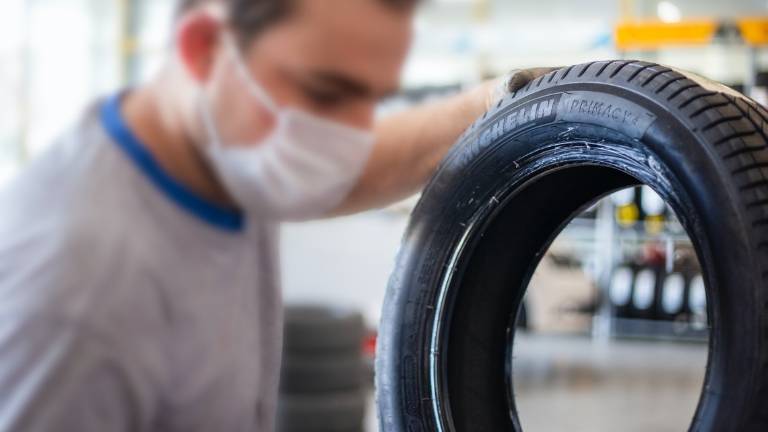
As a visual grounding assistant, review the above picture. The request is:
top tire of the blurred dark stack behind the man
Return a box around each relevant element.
[284,305,365,355]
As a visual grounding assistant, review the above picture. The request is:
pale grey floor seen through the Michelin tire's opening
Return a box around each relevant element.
[368,335,707,432]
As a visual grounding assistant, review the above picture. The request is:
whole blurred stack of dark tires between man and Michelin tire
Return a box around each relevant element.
[277,305,370,432]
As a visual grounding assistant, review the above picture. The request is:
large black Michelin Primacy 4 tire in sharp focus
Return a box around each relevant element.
[377,61,768,432]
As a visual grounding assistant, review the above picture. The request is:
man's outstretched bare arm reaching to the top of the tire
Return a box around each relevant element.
[332,68,556,216]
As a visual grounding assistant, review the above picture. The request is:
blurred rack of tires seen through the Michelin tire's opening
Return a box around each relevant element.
[607,186,707,340]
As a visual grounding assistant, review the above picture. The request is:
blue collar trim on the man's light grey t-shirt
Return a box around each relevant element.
[101,94,245,232]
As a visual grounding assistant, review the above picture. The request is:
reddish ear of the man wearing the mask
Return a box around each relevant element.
[176,9,223,82]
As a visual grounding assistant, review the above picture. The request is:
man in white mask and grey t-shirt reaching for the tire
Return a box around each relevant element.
[0,0,543,432]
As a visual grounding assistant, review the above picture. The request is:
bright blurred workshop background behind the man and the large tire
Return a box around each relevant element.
[0,0,768,431]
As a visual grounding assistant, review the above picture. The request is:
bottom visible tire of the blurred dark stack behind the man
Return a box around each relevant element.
[277,390,368,432]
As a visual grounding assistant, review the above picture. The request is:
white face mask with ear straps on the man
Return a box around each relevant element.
[200,38,374,221]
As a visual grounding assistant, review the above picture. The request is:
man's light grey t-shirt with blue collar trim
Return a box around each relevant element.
[0,96,282,432]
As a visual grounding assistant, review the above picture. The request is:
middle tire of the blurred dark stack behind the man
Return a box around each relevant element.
[280,354,365,394]
